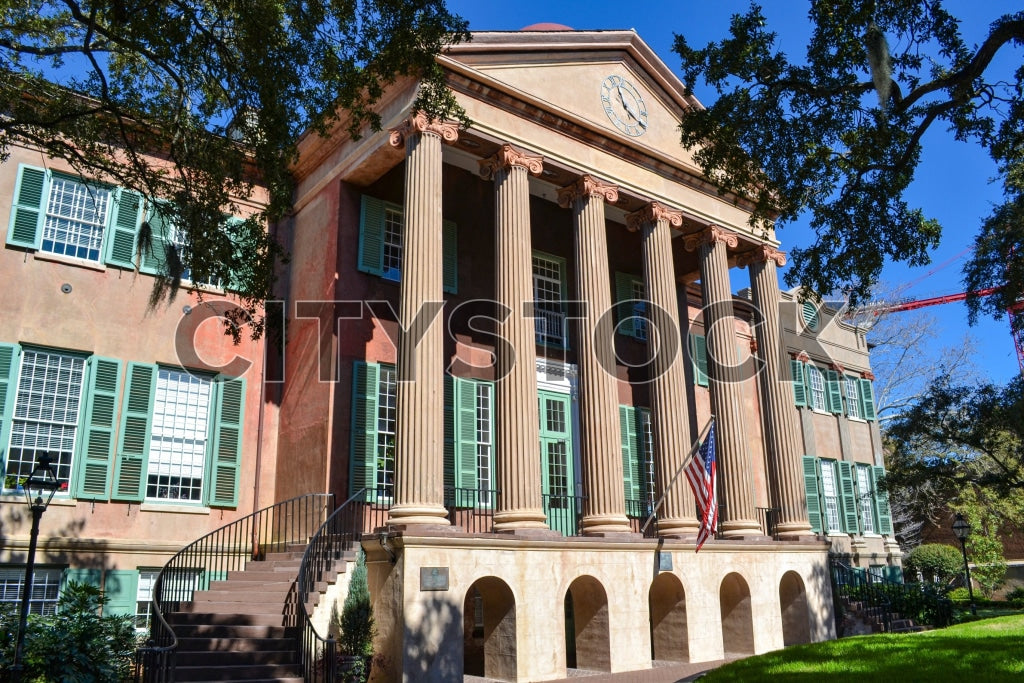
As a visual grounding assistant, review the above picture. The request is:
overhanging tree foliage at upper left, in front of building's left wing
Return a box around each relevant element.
[0,0,468,336]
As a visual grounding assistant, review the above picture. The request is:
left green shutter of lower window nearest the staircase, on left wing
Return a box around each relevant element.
[111,362,157,503]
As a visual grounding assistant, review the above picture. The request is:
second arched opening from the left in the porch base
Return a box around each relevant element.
[565,577,611,671]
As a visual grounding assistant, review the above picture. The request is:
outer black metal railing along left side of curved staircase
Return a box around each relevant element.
[135,494,334,683]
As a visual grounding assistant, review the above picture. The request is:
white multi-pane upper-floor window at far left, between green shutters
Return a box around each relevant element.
[41,175,111,262]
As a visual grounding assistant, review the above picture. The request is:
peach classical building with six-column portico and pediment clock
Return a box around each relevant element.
[0,24,899,681]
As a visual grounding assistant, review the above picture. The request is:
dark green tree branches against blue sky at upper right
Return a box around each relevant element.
[675,0,1024,325]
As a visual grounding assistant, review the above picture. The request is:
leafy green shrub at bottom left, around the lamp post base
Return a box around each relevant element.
[0,582,135,683]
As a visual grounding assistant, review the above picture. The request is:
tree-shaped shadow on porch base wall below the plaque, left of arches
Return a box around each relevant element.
[402,592,463,683]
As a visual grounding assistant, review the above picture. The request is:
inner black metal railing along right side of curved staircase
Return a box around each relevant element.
[295,488,380,683]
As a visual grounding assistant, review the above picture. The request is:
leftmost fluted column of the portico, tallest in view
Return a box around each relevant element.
[388,113,459,525]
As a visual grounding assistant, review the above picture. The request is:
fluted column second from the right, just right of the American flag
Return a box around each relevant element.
[685,225,764,538]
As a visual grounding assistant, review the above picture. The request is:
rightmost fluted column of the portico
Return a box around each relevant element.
[738,245,813,539]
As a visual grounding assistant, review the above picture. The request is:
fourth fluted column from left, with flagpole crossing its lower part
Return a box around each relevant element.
[626,202,697,537]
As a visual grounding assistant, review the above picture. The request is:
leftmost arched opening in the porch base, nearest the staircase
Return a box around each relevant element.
[462,577,517,681]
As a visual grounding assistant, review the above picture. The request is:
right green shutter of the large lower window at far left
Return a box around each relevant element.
[75,355,121,501]
